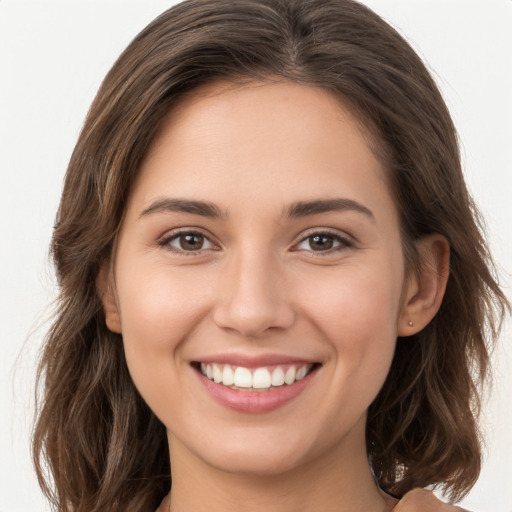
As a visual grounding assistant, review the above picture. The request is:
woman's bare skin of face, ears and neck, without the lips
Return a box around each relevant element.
[100,82,448,512]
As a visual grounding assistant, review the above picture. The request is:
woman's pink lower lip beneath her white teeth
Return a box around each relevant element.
[198,369,317,414]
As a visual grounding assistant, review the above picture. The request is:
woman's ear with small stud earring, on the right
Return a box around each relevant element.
[398,234,450,336]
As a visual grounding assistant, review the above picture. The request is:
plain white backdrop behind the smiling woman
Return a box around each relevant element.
[0,0,512,512]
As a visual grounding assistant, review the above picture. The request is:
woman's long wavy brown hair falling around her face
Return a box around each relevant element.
[33,0,508,512]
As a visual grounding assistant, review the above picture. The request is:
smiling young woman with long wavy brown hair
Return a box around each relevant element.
[34,0,506,511]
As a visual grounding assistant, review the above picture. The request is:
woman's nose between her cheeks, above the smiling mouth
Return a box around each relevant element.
[213,253,295,338]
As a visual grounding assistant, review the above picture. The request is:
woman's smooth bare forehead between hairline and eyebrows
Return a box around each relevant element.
[132,82,387,218]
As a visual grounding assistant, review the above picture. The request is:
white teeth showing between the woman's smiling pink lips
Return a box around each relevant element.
[193,362,320,392]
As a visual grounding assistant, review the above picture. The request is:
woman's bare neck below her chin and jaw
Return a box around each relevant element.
[166,420,396,512]
